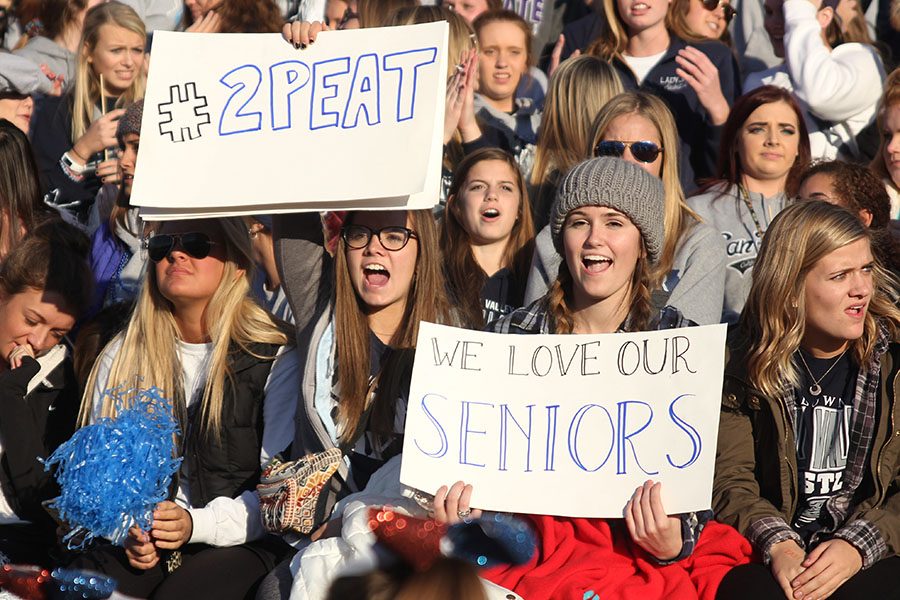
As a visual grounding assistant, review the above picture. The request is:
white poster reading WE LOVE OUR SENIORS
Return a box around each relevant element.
[400,323,726,518]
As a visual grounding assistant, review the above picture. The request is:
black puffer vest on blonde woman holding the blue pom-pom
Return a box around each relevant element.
[184,344,279,508]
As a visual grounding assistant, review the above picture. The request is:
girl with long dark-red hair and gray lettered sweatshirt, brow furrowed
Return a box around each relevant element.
[688,85,809,323]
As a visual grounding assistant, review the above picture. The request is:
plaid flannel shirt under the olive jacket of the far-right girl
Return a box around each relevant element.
[747,328,890,569]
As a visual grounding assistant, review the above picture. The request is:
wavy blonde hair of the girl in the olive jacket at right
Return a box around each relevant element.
[741,201,900,398]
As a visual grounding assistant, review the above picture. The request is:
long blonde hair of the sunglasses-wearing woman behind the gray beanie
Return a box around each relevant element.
[588,92,700,289]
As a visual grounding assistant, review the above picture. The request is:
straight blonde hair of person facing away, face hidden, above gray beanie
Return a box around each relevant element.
[531,56,624,185]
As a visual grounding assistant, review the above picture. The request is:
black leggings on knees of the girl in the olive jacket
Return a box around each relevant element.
[716,556,900,600]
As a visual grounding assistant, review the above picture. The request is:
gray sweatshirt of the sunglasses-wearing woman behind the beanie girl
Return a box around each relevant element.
[525,218,725,325]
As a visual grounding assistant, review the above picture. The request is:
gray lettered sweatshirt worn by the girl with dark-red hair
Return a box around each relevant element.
[688,185,787,323]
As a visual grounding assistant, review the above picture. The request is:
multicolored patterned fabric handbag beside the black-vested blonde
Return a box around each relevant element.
[256,448,344,535]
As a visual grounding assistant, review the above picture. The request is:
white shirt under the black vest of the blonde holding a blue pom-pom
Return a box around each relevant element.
[92,337,300,546]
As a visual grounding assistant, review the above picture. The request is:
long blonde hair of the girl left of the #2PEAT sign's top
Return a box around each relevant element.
[72,0,147,142]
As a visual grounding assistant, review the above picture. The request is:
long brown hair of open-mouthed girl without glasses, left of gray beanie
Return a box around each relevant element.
[441,148,534,329]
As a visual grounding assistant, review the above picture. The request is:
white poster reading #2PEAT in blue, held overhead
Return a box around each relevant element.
[131,22,448,220]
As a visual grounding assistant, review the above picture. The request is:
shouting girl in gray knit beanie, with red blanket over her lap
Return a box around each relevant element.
[435,157,749,600]
